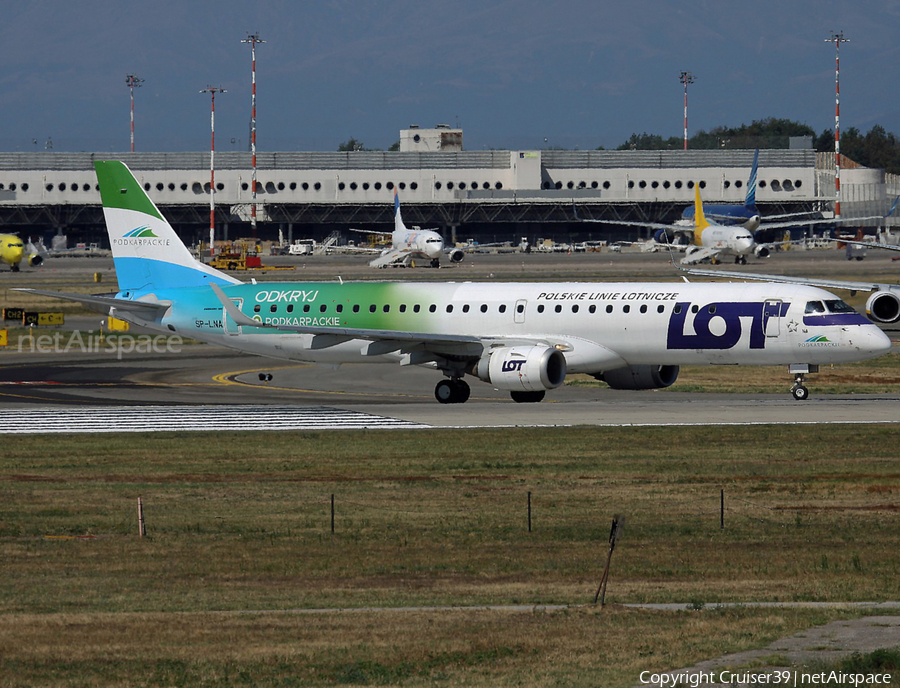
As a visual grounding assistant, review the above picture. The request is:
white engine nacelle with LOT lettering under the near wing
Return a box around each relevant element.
[471,346,566,392]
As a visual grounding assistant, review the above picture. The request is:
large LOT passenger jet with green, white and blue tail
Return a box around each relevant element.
[21,161,891,403]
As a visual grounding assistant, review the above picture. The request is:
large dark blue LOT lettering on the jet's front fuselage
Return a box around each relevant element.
[666,301,790,349]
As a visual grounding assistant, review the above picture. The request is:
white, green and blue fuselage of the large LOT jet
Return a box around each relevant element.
[144,283,890,373]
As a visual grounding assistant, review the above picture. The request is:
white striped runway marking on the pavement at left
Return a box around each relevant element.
[0,405,430,434]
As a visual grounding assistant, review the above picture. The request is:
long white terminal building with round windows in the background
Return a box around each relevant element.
[0,125,900,245]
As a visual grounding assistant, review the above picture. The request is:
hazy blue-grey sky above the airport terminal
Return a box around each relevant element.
[0,0,900,152]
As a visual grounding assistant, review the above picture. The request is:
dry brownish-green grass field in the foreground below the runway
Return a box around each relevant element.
[0,428,900,686]
